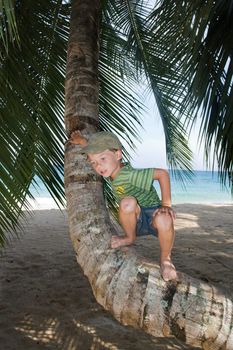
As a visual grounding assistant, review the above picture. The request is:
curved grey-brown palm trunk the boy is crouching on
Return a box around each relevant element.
[65,0,233,350]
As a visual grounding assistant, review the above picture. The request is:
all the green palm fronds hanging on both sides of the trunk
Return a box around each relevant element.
[0,0,233,244]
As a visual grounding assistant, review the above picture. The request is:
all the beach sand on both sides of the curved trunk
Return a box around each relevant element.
[0,204,233,350]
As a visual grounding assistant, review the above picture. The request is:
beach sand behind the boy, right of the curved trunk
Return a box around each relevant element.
[136,204,233,295]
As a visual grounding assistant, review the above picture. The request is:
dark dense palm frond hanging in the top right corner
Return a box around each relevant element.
[150,0,233,187]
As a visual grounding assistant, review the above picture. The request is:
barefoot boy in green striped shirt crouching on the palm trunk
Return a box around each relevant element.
[69,131,177,281]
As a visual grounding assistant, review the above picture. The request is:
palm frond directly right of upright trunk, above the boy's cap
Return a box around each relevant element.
[99,23,143,152]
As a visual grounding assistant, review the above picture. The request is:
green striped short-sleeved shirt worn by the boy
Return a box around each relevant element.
[111,164,161,207]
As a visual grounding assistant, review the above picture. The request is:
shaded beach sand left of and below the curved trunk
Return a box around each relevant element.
[0,210,198,350]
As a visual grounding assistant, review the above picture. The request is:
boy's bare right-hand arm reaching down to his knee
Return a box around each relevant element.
[154,169,175,219]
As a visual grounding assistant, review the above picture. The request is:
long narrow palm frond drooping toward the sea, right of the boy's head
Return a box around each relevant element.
[104,0,192,176]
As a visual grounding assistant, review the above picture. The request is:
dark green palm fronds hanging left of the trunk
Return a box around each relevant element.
[0,1,69,242]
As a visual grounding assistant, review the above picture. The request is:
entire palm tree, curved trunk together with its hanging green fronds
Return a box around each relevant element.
[1,0,233,349]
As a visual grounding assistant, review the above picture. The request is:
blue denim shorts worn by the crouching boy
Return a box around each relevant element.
[136,205,160,236]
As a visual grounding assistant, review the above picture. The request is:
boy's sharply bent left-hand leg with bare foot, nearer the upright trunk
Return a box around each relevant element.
[111,197,140,248]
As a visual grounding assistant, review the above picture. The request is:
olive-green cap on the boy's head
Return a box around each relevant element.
[82,131,122,154]
